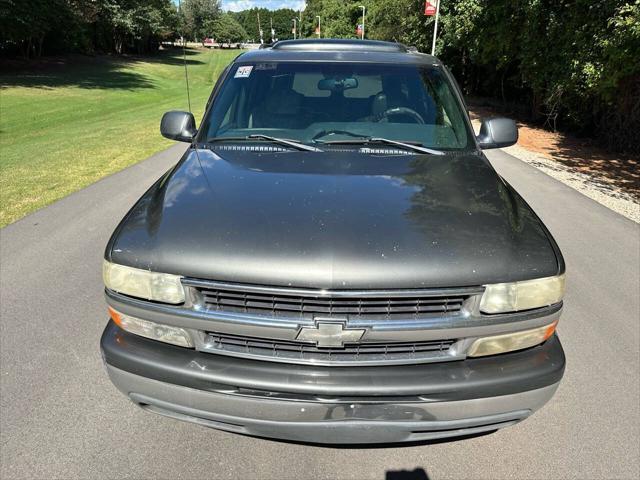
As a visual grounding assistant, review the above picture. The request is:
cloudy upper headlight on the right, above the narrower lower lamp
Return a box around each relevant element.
[480,274,564,313]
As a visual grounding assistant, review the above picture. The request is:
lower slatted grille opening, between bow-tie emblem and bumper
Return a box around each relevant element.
[202,332,457,364]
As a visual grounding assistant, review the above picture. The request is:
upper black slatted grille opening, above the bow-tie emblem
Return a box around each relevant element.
[196,287,468,318]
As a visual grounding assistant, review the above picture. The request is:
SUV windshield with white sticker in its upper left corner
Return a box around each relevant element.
[200,62,473,150]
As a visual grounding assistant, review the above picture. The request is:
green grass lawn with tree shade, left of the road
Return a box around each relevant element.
[0,49,239,226]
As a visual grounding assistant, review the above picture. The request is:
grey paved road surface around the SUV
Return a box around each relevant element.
[0,146,640,479]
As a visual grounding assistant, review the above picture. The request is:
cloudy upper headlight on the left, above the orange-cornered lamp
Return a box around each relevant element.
[102,260,184,304]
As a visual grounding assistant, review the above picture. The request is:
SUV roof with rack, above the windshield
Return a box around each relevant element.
[235,39,441,65]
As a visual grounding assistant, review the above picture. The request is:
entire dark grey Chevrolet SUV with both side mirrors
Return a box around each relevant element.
[101,40,565,448]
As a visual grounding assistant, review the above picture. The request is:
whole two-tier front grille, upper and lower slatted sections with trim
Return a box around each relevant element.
[182,278,483,366]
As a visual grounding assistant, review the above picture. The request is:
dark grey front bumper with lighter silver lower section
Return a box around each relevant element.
[101,322,565,444]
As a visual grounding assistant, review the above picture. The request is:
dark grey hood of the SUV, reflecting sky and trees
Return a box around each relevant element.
[106,150,560,289]
